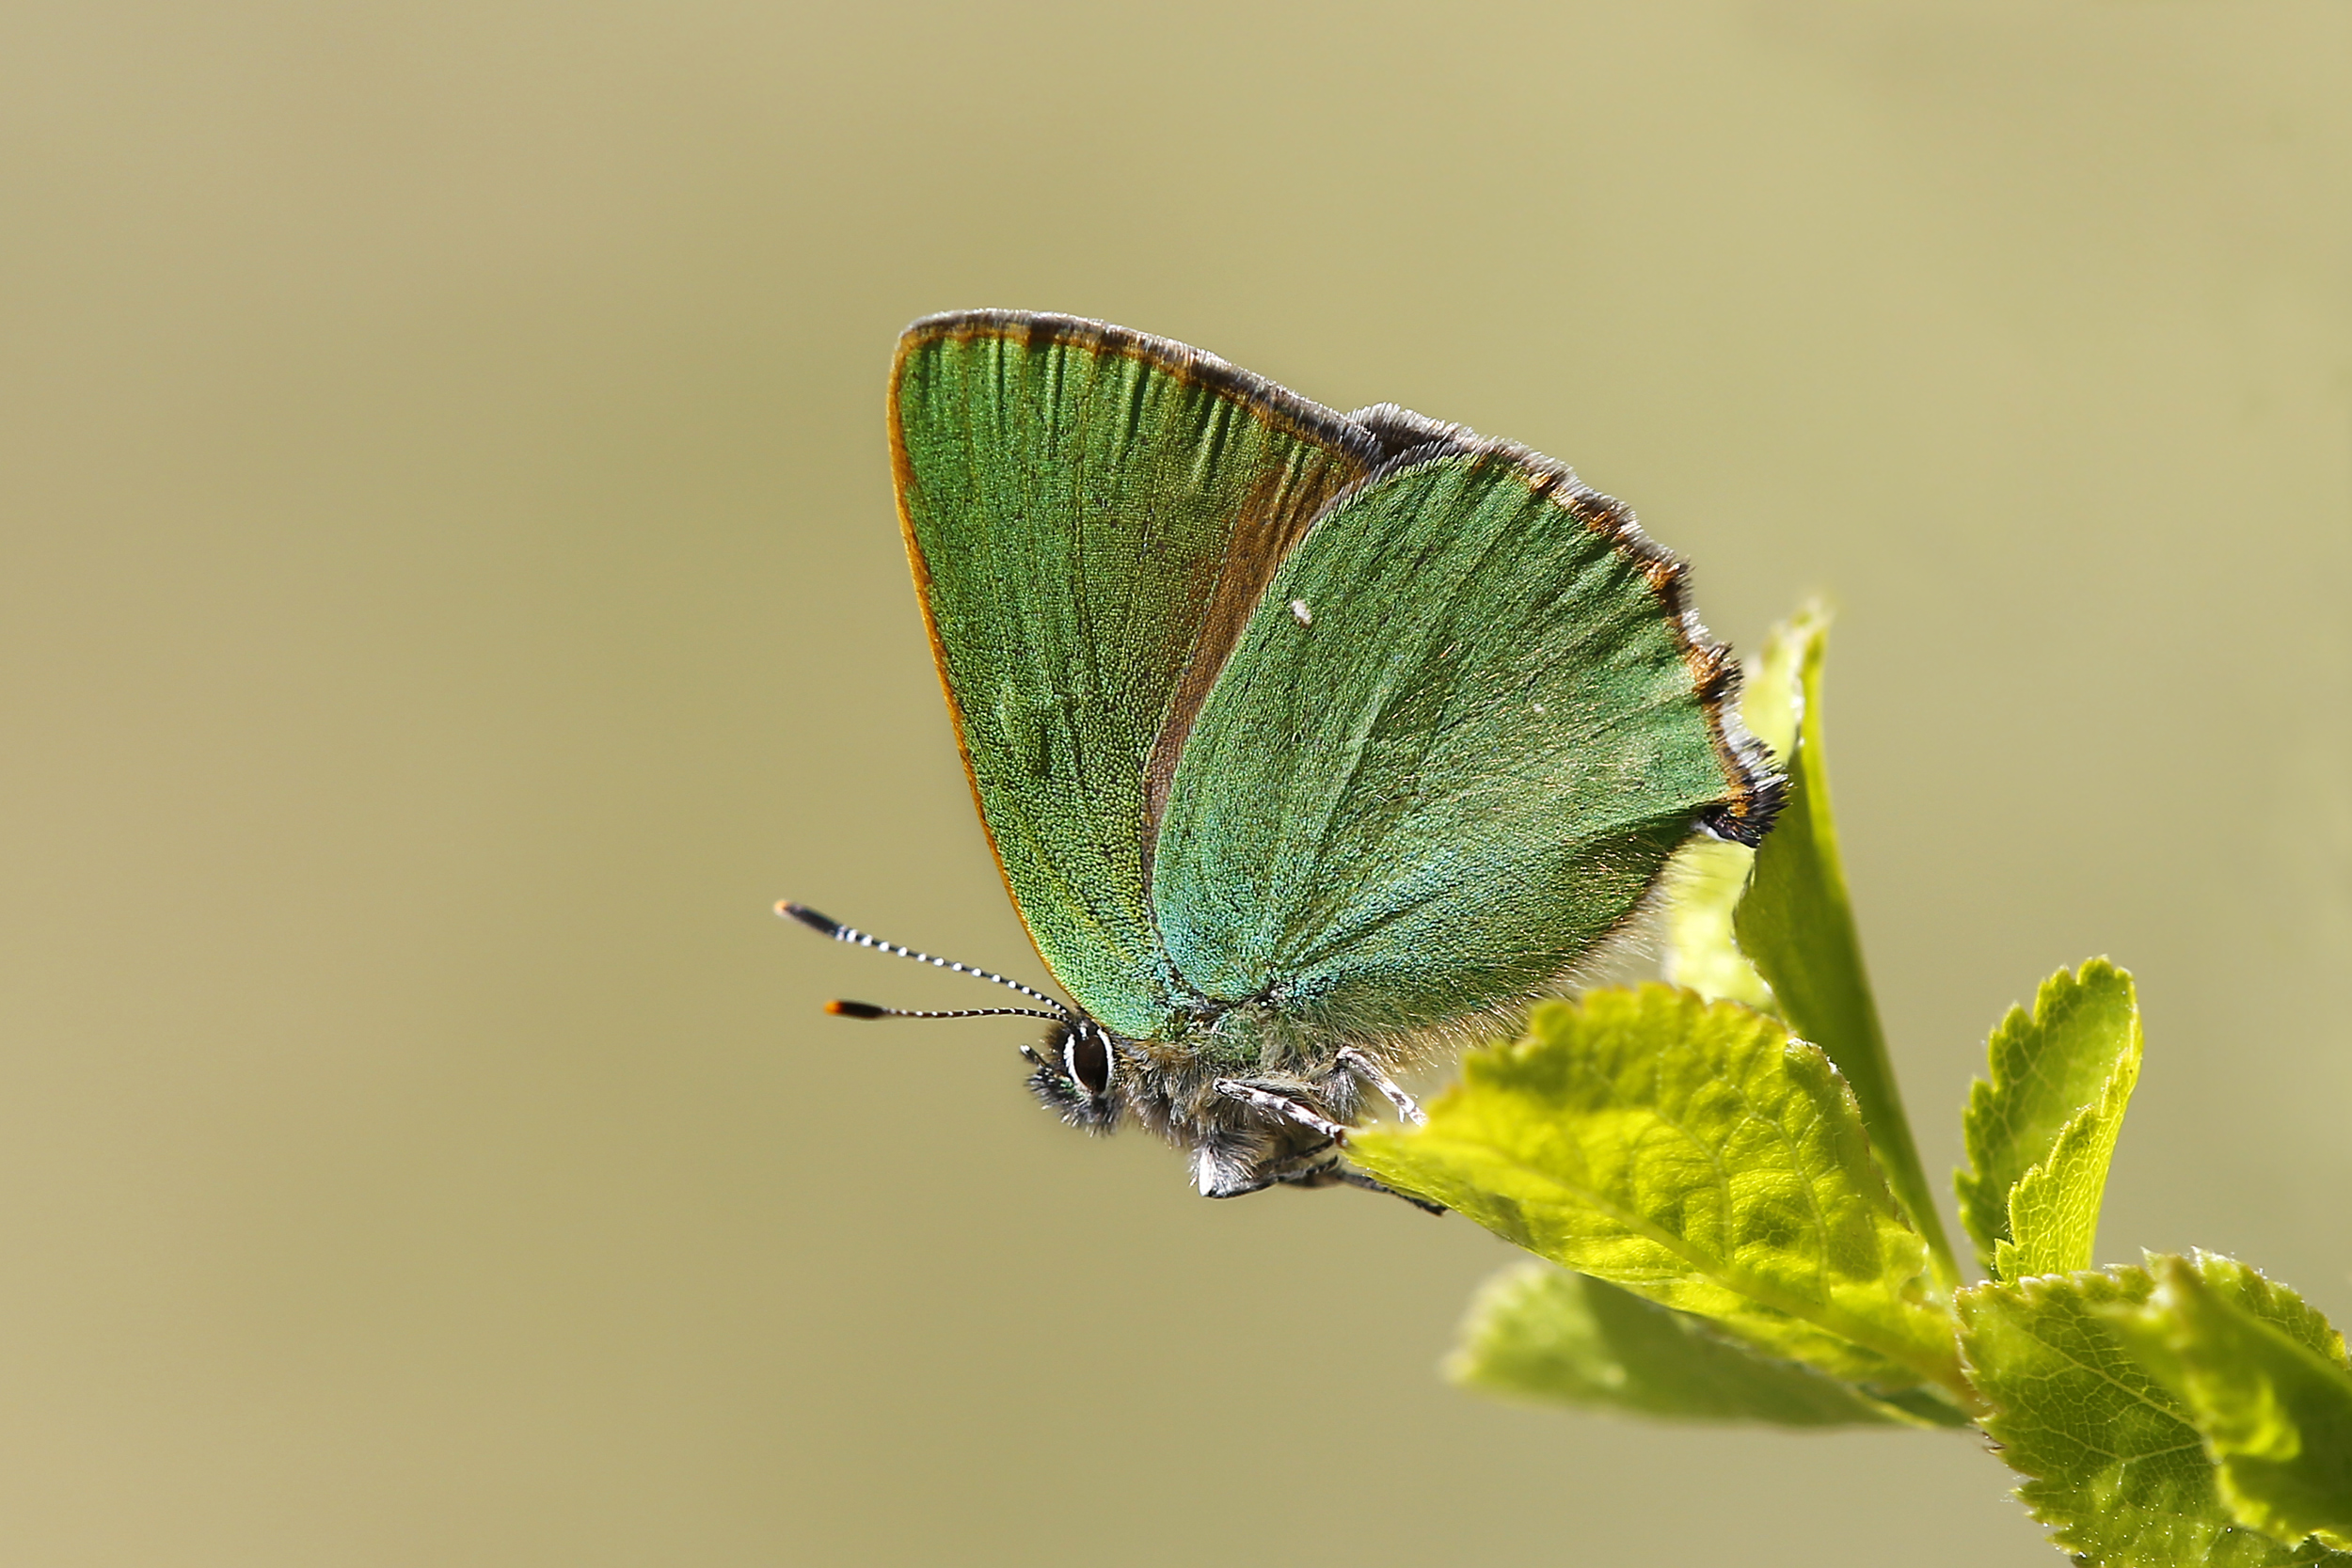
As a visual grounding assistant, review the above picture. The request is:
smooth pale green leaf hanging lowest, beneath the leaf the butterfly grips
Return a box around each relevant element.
[1447,1262,1969,1427]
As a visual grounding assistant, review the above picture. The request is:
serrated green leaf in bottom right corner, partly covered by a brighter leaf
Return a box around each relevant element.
[1957,1258,2352,1568]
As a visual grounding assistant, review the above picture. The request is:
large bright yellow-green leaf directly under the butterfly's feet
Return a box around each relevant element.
[1348,985,1971,1399]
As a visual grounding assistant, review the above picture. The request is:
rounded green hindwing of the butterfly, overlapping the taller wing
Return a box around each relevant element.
[1152,433,1776,1046]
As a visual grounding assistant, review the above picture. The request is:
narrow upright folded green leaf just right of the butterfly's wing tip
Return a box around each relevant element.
[1734,607,1960,1289]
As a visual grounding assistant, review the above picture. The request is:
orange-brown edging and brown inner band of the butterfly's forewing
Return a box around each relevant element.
[889,310,1388,905]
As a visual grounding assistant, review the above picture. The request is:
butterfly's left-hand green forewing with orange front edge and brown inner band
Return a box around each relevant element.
[889,310,1378,1039]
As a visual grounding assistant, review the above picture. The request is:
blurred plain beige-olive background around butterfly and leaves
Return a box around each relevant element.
[0,0,2352,1568]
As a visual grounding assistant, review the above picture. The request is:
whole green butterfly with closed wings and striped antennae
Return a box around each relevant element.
[779,310,1786,1196]
